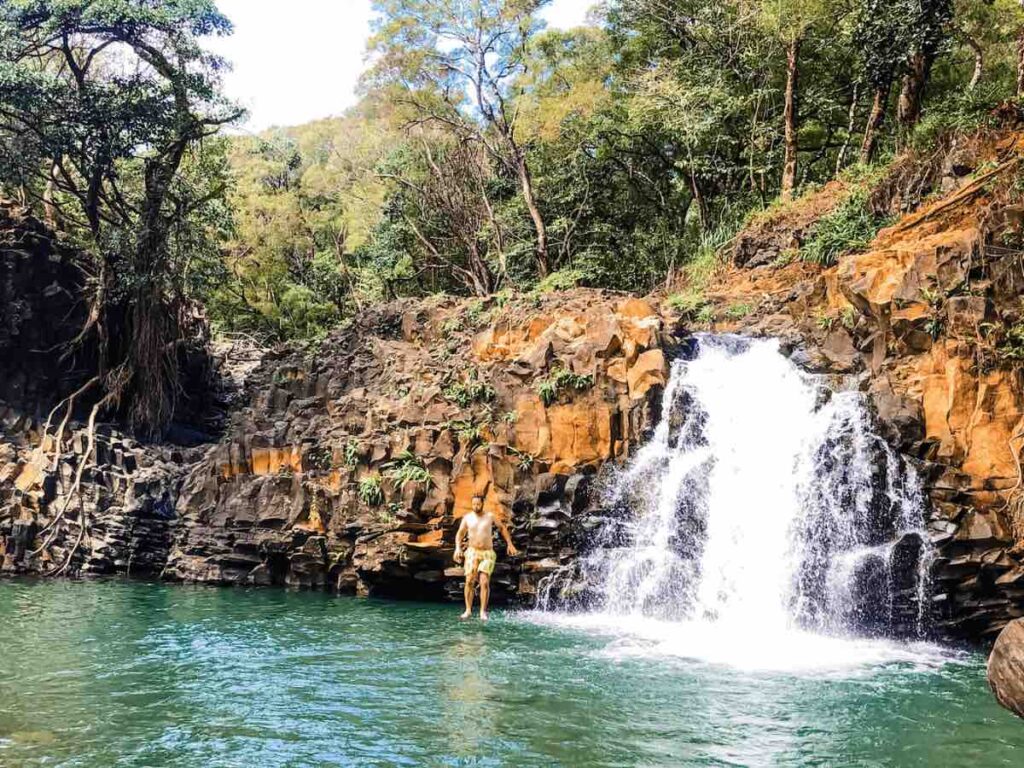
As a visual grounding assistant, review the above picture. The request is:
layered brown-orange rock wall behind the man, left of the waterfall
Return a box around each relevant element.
[165,292,667,599]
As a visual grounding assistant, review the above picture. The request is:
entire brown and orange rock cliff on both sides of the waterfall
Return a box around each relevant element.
[6,129,1024,638]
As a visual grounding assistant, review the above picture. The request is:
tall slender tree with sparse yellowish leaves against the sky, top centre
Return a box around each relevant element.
[372,0,551,276]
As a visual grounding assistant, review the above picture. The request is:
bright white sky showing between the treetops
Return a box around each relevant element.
[210,0,594,132]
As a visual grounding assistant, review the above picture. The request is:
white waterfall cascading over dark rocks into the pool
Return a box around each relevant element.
[541,337,928,667]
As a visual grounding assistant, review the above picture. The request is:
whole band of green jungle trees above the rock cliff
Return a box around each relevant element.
[0,0,1024,430]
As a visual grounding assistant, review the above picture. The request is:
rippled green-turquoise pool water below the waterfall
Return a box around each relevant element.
[0,582,1024,768]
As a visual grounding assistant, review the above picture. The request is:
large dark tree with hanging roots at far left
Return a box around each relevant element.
[0,0,240,433]
